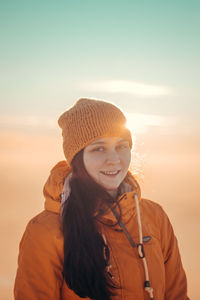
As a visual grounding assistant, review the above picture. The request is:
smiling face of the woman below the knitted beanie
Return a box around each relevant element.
[83,137,131,197]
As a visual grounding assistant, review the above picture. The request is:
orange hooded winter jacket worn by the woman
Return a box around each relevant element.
[14,161,189,300]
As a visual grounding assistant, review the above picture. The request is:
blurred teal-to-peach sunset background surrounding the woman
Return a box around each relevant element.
[0,0,200,300]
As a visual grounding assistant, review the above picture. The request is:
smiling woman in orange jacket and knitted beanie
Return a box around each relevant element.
[14,99,189,300]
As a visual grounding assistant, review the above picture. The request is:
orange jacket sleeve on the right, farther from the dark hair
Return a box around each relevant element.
[161,210,189,300]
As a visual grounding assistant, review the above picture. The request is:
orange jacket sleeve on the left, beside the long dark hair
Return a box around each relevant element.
[14,213,63,300]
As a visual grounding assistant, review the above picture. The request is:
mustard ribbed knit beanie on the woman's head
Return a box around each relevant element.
[58,98,132,164]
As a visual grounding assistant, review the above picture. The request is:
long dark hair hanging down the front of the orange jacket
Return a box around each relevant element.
[62,150,121,300]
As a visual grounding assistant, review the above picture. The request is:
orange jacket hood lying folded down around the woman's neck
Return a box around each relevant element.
[43,161,141,221]
